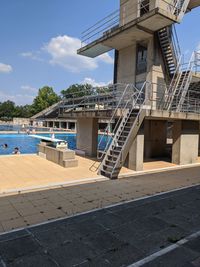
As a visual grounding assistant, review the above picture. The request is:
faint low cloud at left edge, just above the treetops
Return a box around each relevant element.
[0,91,34,105]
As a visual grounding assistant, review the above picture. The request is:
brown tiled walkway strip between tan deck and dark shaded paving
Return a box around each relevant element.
[0,167,200,232]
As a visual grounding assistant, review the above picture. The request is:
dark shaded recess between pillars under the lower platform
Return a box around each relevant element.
[144,120,167,158]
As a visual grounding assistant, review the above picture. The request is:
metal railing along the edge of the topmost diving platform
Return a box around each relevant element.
[81,0,186,47]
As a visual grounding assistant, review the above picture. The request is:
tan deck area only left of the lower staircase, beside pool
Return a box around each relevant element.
[0,155,104,194]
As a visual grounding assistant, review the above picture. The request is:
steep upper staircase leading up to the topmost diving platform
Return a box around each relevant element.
[158,25,181,77]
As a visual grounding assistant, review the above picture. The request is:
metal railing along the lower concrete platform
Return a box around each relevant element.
[59,79,200,116]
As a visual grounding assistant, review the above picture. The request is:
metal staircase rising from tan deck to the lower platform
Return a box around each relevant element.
[99,83,146,179]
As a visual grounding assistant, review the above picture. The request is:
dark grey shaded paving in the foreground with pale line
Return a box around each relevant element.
[0,186,200,267]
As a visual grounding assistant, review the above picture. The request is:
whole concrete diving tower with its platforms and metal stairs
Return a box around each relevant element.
[70,0,200,179]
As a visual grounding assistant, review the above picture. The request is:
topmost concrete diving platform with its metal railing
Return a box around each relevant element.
[78,0,200,58]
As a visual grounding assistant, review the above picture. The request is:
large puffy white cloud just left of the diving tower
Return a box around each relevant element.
[43,35,113,72]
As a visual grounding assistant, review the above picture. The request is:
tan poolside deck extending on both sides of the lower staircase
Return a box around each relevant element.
[0,154,200,196]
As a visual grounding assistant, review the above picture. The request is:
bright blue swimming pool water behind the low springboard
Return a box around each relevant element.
[0,133,111,155]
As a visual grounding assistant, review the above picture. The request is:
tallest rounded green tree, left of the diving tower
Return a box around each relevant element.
[31,86,60,114]
